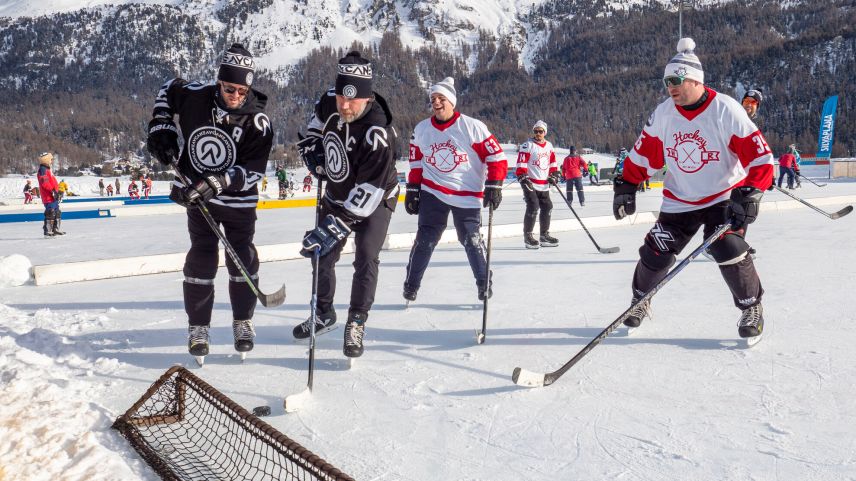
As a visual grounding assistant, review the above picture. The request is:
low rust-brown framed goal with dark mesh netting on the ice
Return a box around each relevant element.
[113,366,353,481]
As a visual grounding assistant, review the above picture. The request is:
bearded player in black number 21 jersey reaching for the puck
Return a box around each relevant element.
[294,51,399,357]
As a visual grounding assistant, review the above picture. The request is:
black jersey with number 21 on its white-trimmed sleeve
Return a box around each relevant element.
[308,90,398,223]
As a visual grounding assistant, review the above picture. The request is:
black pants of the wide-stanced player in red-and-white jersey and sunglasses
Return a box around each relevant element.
[633,201,764,309]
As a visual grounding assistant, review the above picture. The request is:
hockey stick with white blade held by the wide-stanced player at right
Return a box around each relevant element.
[511,223,731,387]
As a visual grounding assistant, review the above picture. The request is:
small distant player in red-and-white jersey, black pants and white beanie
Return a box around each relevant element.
[514,120,561,249]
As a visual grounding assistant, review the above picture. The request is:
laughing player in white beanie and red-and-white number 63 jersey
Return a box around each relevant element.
[404,77,508,301]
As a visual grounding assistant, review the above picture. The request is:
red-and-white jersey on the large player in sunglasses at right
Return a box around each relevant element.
[623,87,773,212]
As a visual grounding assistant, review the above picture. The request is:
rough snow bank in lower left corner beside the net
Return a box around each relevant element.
[0,304,143,480]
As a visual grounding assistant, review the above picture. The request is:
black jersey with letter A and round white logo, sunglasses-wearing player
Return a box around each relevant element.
[152,78,273,208]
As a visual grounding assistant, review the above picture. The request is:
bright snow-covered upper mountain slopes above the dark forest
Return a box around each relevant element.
[0,0,727,77]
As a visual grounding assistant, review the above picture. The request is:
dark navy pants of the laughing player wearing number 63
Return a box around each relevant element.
[404,190,487,290]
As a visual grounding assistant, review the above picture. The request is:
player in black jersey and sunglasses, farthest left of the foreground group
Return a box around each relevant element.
[147,43,273,357]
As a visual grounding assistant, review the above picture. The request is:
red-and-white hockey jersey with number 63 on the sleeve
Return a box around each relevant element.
[407,112,508,208]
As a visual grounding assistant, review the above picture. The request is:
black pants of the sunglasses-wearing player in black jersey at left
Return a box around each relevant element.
[184,203,259,326]
